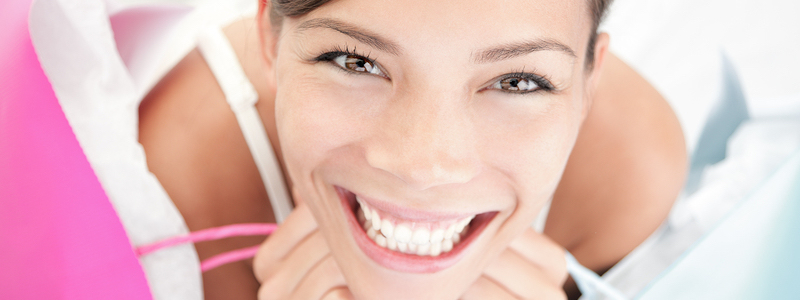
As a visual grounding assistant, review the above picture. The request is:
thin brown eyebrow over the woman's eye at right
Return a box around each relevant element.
[473,39,577,64]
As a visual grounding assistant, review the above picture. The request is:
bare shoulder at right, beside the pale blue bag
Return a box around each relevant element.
[546,55,688,272]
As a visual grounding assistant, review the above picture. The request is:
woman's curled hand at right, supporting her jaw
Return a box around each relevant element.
[462,229,567,300]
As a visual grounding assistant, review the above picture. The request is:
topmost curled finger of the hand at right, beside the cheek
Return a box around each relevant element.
[509,228,567,285]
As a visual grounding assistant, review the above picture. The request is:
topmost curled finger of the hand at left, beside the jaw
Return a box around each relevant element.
[253,205,317,282]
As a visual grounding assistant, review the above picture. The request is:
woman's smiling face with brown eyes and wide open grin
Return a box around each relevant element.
[274,0,591,299]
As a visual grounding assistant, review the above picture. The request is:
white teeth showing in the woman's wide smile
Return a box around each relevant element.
[356,196,475,256]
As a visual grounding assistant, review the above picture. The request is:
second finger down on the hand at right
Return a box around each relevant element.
[483,250,563,299]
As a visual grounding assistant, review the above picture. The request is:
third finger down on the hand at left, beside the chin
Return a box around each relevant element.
[290,255,346,300]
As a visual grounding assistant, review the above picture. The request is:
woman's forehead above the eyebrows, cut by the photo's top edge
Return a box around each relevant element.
[284,0,591,57]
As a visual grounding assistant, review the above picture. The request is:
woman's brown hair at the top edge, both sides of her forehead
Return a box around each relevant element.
[268,0,613,69]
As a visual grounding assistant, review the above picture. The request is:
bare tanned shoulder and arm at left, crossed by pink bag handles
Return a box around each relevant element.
[139,17,282,299]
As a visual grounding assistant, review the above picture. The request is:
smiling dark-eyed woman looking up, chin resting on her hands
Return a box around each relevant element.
[139,0,686,299]
